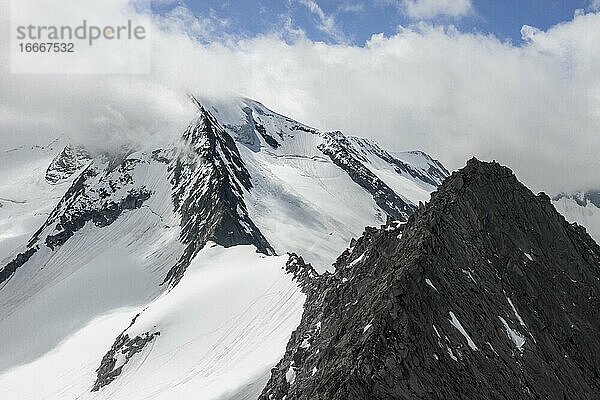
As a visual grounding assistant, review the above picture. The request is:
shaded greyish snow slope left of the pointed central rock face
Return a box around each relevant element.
[0,153,182,371]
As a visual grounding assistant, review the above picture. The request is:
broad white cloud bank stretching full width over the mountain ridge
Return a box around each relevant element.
[0,0,600,192]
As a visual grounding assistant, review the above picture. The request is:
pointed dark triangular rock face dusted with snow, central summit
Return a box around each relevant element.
[159,104,274,286]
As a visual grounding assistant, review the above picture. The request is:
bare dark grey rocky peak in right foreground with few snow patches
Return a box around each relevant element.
[260,159,600,400]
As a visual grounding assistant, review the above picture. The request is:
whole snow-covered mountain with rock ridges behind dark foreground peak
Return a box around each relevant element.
[0,99,448,399]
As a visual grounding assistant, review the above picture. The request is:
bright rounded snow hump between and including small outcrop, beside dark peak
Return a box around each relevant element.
[88,242,304,400]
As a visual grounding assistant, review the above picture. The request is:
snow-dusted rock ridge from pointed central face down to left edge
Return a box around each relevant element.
[0,104,274,285]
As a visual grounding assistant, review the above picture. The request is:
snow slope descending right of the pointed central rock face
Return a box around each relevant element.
[203,99,448,271]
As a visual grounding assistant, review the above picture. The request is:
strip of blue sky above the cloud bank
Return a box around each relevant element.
[159,0,600,46]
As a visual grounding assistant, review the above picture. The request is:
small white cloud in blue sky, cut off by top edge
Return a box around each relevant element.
[400,0,474,19]
